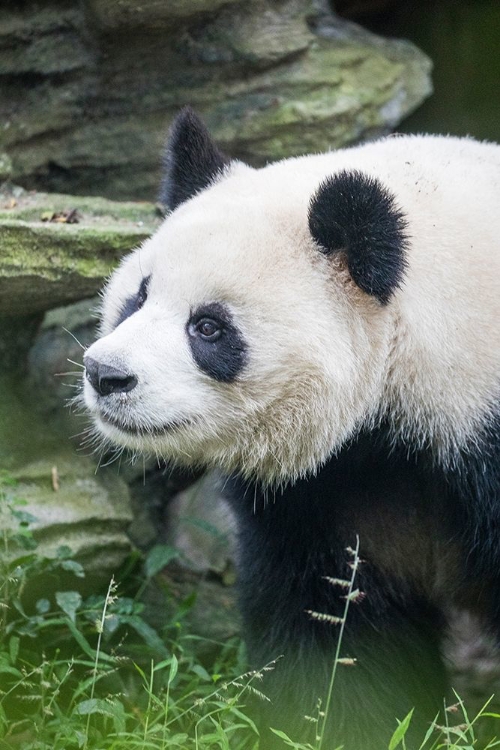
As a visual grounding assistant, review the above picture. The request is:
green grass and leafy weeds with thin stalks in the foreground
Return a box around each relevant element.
[0,474,500,750]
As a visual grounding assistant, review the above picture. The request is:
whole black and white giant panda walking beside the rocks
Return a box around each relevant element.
[84,109,500,750]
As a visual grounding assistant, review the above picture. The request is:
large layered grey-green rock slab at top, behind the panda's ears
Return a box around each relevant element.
[0,0,431,200]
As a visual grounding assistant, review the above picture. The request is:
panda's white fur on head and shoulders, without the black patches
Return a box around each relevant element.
[85,136,500,481]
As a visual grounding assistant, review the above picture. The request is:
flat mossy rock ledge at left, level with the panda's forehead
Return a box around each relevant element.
[0,187,160,317]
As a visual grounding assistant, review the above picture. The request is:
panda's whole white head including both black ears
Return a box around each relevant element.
[84,109,406,483]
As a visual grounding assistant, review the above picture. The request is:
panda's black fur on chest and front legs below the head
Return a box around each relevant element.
[229,418,500,750]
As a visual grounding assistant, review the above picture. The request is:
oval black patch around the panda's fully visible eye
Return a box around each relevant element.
[186,302,248,383]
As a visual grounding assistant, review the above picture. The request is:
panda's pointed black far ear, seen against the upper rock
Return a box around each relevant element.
[158,107,230,210]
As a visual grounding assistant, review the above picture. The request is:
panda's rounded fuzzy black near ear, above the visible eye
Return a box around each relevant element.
[309,170,408,304]
